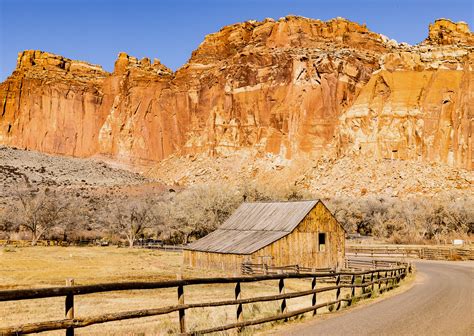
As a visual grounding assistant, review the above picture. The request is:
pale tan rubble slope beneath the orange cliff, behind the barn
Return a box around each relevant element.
[147,152,474,200]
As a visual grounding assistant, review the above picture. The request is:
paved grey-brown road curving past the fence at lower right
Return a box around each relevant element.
[279,261,474,336]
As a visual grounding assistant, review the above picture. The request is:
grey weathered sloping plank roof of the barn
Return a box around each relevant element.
[185,200,319,254]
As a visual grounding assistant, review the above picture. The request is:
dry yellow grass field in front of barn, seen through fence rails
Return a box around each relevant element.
[0,247,354,335]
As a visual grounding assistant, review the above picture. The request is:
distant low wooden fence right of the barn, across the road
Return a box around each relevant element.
[346,245,474,260]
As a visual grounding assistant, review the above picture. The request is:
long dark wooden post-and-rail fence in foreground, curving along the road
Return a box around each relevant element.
[0,264,409,335]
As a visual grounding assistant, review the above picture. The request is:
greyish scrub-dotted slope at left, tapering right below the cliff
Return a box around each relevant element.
[0,146,166,209]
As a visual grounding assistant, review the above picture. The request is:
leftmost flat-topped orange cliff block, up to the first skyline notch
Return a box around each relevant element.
[0,51,107,156]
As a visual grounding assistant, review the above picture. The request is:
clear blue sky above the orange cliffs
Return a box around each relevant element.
[0,0,474,81]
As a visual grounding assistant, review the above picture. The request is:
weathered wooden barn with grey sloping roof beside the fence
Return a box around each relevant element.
[184,200,345,271]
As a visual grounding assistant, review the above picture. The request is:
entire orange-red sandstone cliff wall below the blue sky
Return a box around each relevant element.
[0,16,474,169]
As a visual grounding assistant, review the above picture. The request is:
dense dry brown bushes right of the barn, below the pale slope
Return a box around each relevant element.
[328,193,474,244]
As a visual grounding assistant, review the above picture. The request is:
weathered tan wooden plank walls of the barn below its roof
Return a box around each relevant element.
[184,202,345,271]
